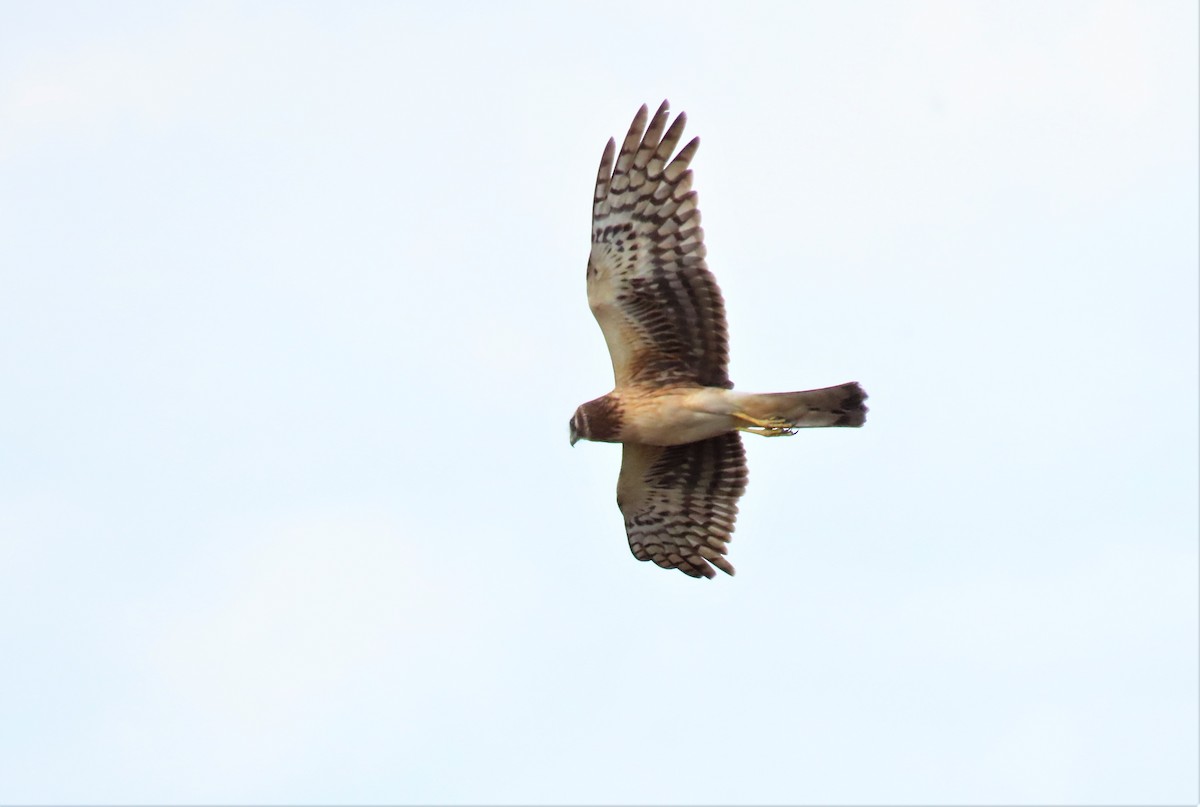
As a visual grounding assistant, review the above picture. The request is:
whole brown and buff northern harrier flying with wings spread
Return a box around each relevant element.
[571,101,866,578]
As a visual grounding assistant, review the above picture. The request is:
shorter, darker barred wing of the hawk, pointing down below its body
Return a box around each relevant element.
[617,431,748,578]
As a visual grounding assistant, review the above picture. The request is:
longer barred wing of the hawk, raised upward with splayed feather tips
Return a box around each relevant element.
[588,101,733,388]
